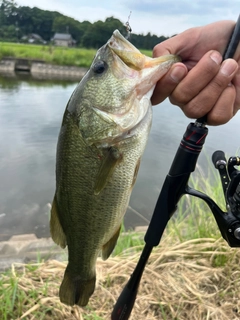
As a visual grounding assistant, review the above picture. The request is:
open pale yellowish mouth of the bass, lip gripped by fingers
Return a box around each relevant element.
[107,30,181,71]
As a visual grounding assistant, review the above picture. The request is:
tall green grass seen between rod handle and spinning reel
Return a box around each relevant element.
[167,163,226,242]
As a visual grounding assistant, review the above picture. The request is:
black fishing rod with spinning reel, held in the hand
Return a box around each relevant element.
[111,15,240,320]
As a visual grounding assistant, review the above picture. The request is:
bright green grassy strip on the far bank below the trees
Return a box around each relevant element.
[0,42,151,68]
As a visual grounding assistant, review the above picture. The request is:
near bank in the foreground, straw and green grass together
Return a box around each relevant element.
[0,164,240,320]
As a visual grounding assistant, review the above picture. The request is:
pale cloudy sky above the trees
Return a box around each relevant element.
[16,0,240,36]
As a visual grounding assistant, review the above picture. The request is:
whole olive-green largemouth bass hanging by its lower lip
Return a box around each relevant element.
[50,30,178,306]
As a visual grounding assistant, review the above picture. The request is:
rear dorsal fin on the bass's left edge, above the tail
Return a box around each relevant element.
[50,195,67,248]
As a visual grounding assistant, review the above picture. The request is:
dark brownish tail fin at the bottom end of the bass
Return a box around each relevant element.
[59,267,96,307]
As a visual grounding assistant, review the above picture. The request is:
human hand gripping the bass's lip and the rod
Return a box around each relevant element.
[152,21,240,125]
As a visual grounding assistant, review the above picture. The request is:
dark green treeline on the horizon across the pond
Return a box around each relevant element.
[0,0,169,50]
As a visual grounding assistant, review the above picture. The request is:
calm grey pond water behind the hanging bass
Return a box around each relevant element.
[0,76,240,240]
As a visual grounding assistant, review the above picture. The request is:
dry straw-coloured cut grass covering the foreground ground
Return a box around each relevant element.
[0,236,240,320]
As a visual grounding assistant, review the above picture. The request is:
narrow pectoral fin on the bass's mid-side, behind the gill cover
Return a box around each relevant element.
[94,147,122,195]
